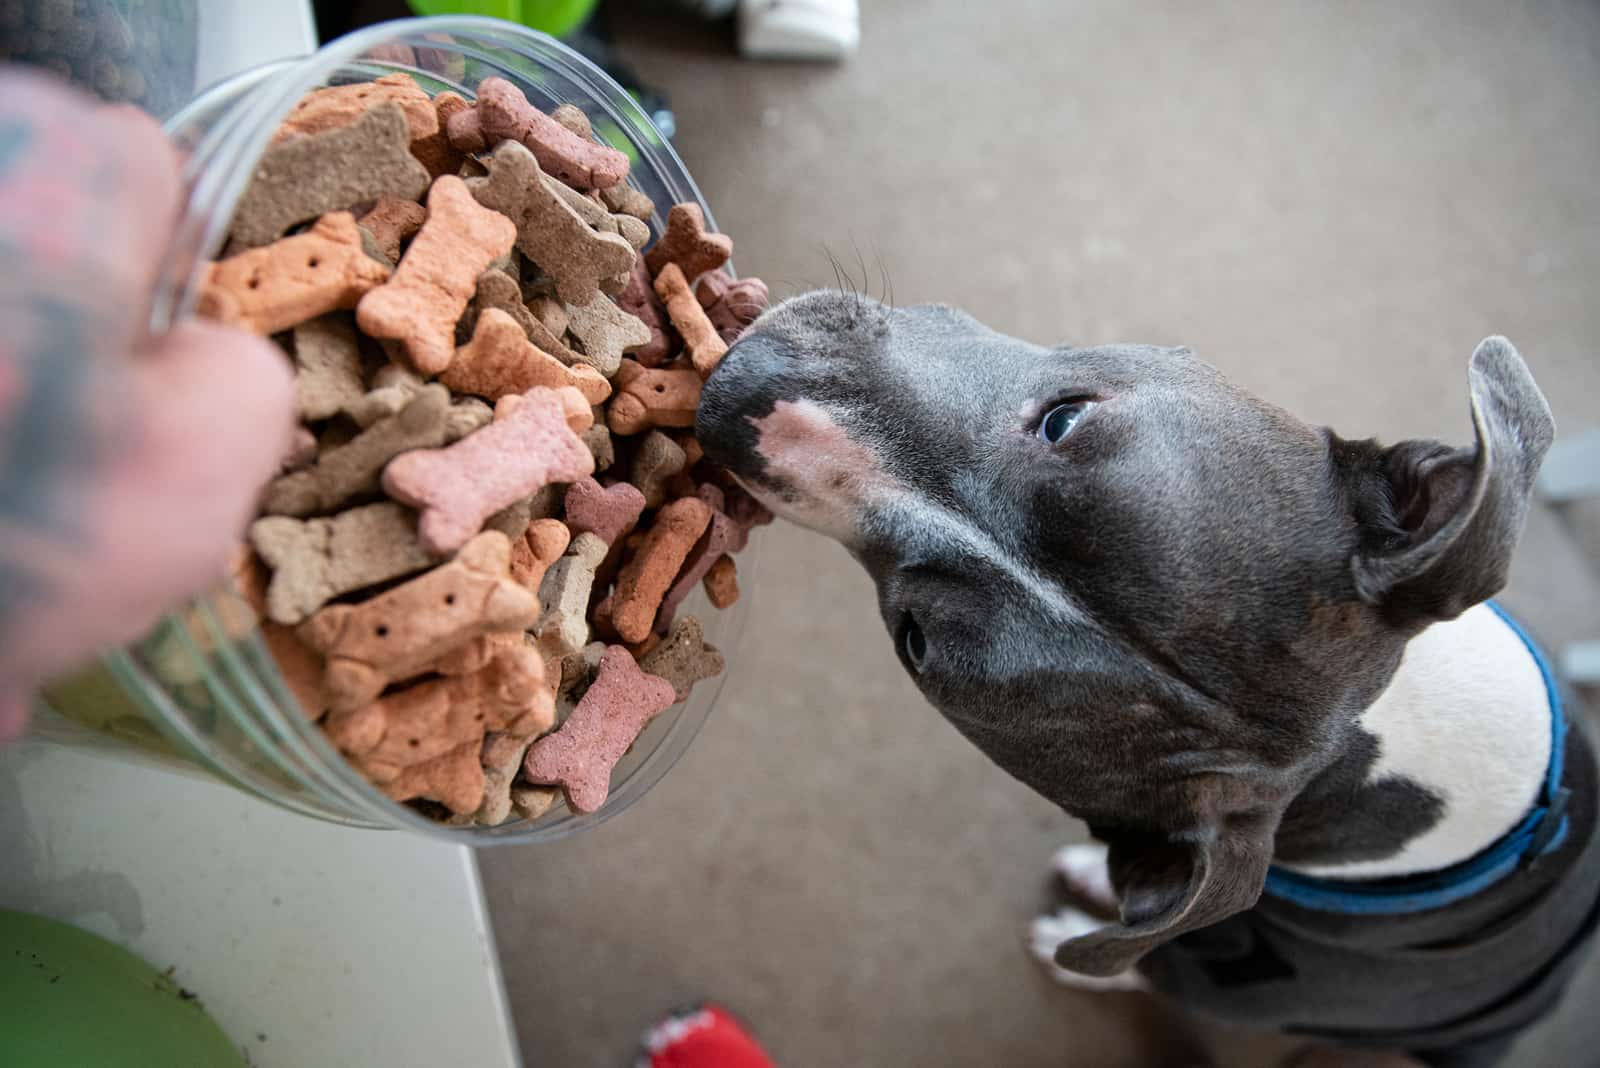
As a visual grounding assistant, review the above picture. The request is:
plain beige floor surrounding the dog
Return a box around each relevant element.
[483,0,1600,1068]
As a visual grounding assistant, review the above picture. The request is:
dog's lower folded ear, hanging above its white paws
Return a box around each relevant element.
[1056,807,1282,975]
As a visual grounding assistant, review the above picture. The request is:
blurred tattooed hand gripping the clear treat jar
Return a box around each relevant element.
[0,67,291,740]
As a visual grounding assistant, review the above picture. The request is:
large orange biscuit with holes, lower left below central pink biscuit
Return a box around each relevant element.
[298,531,539,711]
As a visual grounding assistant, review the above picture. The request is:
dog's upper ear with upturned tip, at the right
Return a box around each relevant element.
[1352,337,1555,624]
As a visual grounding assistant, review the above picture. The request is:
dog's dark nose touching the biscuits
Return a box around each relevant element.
[694,334,795,475]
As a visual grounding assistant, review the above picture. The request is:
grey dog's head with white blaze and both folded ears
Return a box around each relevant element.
[698,293,1552,974]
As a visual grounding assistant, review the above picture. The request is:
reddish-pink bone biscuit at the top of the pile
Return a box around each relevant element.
[448,78,627,190]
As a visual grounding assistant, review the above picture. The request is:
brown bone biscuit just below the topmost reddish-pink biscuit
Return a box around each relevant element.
[467,141,635,304]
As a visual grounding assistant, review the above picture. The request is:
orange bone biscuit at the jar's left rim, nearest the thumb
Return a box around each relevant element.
[198,211,389,334]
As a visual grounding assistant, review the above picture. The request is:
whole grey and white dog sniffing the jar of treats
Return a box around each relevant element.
[696,291,1600,1065]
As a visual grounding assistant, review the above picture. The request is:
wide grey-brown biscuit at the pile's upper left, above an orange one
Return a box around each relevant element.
[230,104,427,248]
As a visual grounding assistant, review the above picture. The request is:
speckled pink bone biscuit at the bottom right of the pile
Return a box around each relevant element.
[522,646,674,812]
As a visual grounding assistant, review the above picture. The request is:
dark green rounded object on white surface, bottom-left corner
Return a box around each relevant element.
[0,910,246,1068]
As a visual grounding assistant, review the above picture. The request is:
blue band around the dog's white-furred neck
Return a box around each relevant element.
[1266,601,1568,916]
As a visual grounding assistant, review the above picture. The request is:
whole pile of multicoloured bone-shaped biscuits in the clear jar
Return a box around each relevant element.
[200,75,771,823]
